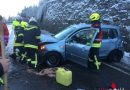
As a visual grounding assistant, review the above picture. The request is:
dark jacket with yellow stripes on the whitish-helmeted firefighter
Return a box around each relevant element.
[24,25,41,49]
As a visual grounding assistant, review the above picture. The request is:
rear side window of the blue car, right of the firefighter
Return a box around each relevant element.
[102,28,118,39]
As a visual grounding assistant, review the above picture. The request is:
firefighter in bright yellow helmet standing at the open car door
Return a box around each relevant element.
[88,13,103,71]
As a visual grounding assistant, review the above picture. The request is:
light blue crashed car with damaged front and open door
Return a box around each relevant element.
[39,23,123,66]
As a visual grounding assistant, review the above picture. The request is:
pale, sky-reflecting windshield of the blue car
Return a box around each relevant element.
[54,26,75,40]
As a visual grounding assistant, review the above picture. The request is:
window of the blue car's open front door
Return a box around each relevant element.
[71,30,95,46]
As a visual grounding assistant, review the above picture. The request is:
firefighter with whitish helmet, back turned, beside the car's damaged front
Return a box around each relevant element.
[24,18,41,69]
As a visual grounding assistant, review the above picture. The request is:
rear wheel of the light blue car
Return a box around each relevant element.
[107,50,123,62]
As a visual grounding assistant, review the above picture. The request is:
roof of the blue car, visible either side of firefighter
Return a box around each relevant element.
[72,23,119,29]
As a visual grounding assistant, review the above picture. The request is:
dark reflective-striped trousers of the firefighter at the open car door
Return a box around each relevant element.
[88,47,101,70]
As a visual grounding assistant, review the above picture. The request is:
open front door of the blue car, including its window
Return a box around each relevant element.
[65,28,97,66]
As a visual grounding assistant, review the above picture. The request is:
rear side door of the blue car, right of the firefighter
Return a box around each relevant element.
[100,28,118,57]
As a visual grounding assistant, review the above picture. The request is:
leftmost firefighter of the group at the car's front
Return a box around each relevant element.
[10,17,24,59]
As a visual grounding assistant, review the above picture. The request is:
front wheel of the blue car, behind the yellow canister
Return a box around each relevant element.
[46,53,61,67]
